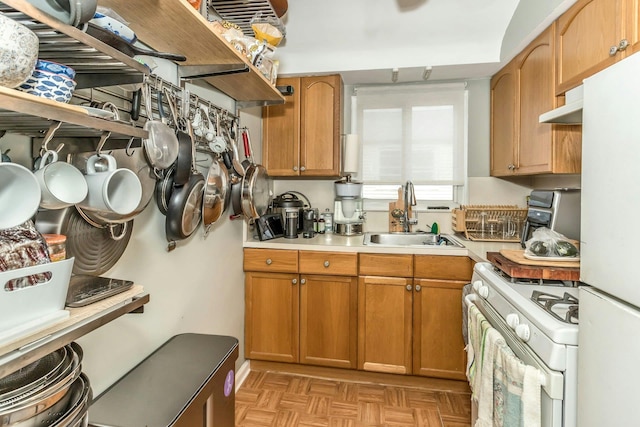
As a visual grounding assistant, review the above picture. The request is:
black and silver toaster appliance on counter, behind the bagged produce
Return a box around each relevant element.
[520,188,580,248]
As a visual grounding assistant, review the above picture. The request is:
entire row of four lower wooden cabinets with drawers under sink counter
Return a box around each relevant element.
[245,249,473,380]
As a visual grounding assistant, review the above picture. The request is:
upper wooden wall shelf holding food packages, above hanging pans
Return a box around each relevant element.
[100,0,284,106]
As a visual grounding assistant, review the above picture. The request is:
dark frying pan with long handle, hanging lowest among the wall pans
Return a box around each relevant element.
[165,123,205,251]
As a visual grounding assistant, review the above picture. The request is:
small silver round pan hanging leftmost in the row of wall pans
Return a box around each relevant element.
[143,84,178,176]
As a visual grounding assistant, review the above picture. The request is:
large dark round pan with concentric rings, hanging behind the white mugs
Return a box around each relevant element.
[36,206,133,276]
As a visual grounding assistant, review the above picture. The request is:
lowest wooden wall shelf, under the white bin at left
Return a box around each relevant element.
[0,285,149,378]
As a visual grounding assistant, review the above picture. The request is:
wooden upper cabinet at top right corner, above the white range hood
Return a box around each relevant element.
[556,0,638,95]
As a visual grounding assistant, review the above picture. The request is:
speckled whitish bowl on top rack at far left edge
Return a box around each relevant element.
[0,15,38,88]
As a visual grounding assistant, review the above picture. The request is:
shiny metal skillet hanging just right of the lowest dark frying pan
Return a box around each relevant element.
[202,157,231,237]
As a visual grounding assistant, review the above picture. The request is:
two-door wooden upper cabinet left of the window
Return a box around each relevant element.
[262,74,343,177]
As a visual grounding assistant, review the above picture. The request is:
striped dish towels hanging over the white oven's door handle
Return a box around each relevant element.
[466,305,541,427]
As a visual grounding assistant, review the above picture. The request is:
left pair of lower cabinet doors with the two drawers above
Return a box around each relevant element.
[245,249,358,369]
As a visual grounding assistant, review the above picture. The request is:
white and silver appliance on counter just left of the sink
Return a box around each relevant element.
[334,175,364,236]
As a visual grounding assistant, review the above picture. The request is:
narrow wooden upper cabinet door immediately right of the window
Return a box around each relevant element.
[491,62,516,176]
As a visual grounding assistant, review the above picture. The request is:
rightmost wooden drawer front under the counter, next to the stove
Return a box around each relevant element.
[413,255,473,281]
